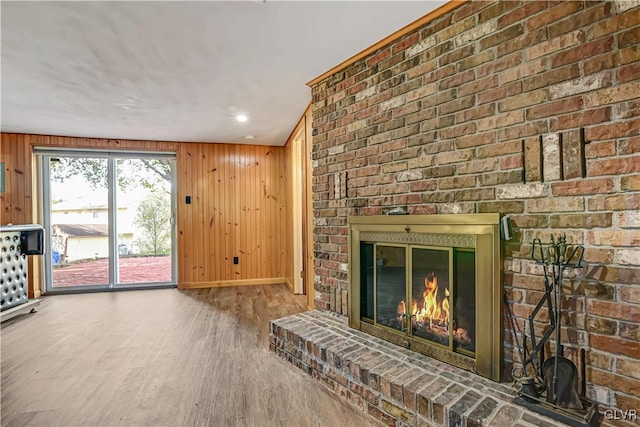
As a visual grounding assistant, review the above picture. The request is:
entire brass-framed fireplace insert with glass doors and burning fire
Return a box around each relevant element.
[349,214,502,381]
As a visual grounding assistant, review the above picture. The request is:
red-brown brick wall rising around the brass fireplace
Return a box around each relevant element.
[312,1,640,409]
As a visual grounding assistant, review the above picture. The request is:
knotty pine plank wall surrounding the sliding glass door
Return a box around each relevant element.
[0,133,288,297]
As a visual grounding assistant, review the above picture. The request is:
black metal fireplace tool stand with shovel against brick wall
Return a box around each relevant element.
[507,234,600,427]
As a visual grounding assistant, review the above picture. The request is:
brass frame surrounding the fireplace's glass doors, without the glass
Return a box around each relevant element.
[348,213,503,381]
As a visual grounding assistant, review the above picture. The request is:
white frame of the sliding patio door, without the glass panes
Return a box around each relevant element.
[34,147,178,294]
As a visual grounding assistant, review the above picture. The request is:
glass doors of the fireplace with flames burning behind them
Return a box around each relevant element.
[360,242,476,356]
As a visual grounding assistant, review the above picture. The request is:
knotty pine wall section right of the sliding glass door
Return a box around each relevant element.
[178,144,288,287]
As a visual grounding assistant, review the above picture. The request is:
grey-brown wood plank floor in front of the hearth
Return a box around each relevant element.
[0,285,378,426]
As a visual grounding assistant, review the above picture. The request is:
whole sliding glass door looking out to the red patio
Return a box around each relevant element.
[36,149,176,292]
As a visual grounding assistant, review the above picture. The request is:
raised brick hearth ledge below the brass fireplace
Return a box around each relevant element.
[270,310,558,427]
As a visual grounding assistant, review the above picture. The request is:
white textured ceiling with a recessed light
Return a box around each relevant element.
[0,1,446,145]
